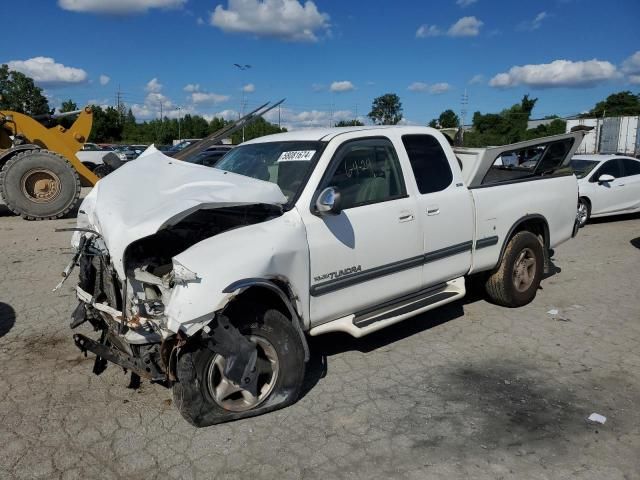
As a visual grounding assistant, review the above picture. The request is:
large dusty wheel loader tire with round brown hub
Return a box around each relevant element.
[0,150,80,220]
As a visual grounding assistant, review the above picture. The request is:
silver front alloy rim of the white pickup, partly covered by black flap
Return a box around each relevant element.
[207,335,280,412]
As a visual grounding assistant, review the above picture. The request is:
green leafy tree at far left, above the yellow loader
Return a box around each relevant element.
[0,64,53,116]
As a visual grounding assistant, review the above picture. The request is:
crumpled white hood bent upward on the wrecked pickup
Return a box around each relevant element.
[78,147,287,275]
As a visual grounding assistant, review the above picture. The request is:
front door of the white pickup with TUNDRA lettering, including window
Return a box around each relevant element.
[301,137,422,325]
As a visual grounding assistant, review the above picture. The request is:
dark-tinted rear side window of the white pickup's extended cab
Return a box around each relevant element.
[402,135,453,193]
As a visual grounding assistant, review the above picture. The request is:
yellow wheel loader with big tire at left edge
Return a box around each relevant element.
[0,107,98,220]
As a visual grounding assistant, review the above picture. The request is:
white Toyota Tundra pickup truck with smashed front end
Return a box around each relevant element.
[65,126,584,426]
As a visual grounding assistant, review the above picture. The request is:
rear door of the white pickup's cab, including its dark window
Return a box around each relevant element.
[402,134,474,287]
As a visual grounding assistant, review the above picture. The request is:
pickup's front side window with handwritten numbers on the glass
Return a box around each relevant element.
[326,139,406,209]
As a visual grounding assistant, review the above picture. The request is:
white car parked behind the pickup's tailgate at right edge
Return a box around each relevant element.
[571,155,640,226]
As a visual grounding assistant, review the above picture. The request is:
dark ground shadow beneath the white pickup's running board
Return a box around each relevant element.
[299,291,470,399]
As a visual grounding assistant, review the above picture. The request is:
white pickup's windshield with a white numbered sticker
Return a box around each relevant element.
[216,142,323,201]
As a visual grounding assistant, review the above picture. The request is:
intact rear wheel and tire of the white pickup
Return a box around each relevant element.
[485,231,544,307]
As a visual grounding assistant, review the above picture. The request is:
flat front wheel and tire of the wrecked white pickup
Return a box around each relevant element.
[173,310,305,427]
